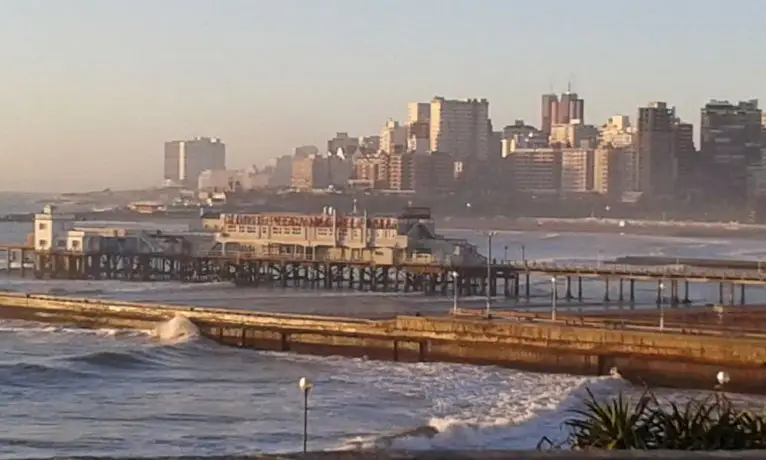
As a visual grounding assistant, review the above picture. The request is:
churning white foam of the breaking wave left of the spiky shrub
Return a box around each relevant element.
[337,372,626,450]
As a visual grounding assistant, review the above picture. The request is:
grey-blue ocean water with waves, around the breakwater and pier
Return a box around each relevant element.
[0,196,766,458]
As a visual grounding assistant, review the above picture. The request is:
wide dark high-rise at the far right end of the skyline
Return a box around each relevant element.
[700,100,763,202]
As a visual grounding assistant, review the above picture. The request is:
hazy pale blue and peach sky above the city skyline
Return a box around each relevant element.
[0,0,766,191]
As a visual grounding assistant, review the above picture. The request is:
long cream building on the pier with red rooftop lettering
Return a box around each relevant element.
[204,208,484,265]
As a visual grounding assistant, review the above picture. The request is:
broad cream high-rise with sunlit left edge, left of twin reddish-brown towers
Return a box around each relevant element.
[430,97,490,161]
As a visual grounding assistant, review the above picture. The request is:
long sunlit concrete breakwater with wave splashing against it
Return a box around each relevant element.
[0,294,766,394]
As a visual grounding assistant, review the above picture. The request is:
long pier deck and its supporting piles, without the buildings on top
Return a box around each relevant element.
[0,246,766,306]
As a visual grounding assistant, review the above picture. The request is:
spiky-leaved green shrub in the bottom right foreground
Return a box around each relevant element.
[541,389,766,450]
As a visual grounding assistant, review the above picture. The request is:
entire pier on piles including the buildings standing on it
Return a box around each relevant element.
[0,206,766,306]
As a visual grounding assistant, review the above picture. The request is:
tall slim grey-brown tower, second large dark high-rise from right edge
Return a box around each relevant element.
[635,102,677,197]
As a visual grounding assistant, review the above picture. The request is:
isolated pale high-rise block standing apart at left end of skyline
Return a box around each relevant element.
[164,137,226,188]
